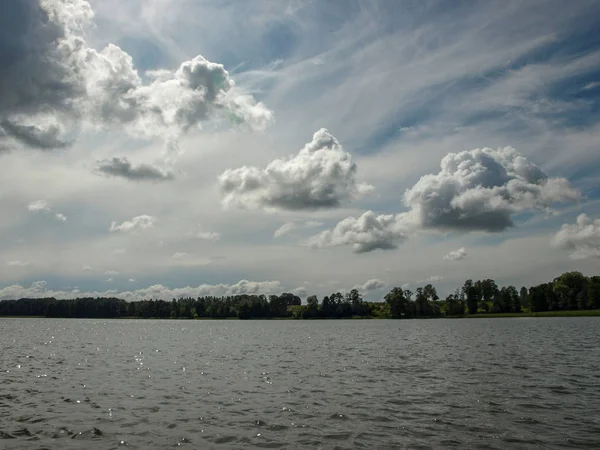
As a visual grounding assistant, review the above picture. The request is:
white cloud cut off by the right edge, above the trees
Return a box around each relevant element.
[552,214,600,259]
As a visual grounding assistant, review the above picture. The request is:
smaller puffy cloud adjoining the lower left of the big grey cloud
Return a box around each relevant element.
[308,211,406,253]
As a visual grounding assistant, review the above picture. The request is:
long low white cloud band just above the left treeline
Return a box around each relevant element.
[0,280,283,301]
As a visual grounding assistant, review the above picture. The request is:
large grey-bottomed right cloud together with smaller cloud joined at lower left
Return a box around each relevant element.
[312,147,580,253]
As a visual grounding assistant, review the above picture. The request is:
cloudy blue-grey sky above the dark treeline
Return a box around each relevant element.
[0,0,600,301]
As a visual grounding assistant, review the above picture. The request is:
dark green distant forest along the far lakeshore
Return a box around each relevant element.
[0,272,600,319]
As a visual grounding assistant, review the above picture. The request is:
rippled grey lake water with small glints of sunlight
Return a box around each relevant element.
[0,318,600,449]
